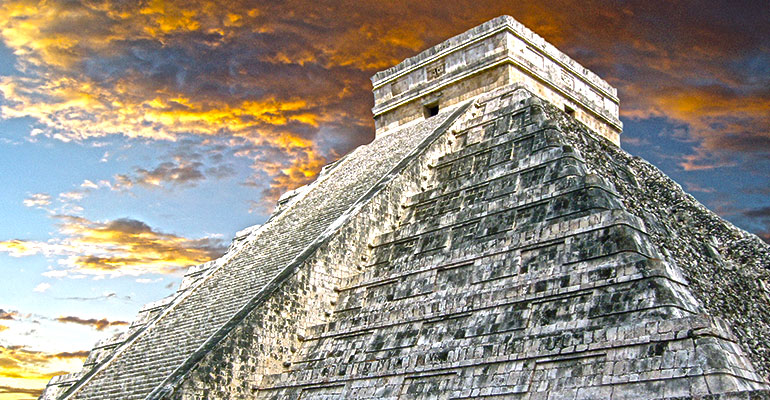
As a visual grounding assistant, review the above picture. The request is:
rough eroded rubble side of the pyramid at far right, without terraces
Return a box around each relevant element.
[548,107,770,380]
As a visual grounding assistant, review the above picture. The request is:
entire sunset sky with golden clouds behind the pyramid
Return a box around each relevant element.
[0,0,770,399]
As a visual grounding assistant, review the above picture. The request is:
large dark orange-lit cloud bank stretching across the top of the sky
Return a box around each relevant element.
[0,0,770,225]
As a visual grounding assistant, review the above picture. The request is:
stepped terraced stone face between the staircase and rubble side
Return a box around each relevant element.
[254,89,768,400]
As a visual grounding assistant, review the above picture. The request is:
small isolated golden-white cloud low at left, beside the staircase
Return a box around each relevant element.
[0,215,226,277]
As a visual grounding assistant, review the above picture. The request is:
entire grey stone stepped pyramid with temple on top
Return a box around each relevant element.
[41,16,770,400]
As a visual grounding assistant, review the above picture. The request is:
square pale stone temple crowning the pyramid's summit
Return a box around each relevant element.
[372,15,623,145]
